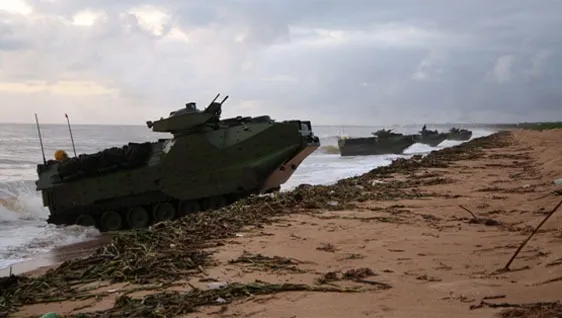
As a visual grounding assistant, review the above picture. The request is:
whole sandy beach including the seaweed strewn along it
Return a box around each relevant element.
[0,129,562,318]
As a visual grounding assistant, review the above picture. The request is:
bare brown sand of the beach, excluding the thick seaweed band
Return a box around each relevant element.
[4,130,562,318]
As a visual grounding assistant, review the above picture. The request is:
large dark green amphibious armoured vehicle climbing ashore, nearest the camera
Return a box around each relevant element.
[36,94,320,232]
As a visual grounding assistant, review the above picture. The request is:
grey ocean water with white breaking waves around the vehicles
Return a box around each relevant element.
[0,124,493,269]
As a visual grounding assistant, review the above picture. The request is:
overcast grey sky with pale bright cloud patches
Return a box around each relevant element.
[0,0,562,125]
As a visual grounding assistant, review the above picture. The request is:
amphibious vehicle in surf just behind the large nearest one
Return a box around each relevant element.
[338,129,415,156]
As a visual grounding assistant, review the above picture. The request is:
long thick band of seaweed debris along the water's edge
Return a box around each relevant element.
[0,132,510,316]
